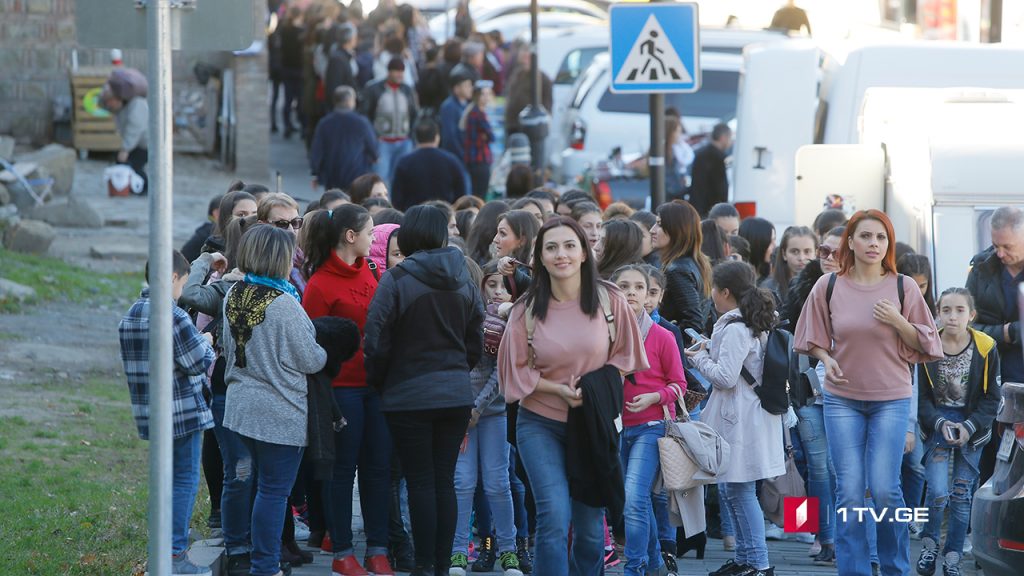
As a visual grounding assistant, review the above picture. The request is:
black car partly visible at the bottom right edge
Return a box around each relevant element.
[971,382,1024,576]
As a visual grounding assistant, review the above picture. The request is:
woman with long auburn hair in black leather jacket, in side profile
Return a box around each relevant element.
[650,200,711,345]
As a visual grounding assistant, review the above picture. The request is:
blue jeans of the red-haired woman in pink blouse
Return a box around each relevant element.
[824,393,910,576]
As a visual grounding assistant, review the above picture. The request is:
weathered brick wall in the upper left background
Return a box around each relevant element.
[0,0,268,171]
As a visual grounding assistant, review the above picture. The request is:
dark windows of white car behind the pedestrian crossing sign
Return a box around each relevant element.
[597,70,739,121]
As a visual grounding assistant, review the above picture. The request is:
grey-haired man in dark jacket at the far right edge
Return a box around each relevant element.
[967,206,1024,484]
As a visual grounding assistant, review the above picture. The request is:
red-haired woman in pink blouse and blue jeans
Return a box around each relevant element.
[794,210,942,576]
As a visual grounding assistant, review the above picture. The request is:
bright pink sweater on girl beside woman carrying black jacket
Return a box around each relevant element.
[623,324,686,426]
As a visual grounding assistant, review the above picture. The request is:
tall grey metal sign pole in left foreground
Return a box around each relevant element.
[145,0,174,576]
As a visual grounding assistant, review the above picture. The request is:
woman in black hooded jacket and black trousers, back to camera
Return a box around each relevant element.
[364,206,483,576]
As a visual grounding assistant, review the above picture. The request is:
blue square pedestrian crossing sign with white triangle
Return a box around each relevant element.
[610,2,700,93]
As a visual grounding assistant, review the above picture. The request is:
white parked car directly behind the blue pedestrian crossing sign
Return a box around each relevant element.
[549,52,741,182]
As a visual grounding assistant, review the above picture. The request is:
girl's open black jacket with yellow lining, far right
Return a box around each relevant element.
[918,328,1002,448]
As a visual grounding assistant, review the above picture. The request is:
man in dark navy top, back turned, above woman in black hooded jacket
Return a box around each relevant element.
[391,118,466,212]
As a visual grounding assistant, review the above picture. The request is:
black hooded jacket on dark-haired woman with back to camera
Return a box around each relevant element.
[364,247,483,412]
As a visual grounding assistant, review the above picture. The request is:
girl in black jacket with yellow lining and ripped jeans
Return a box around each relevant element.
[918,288,1000,576]
